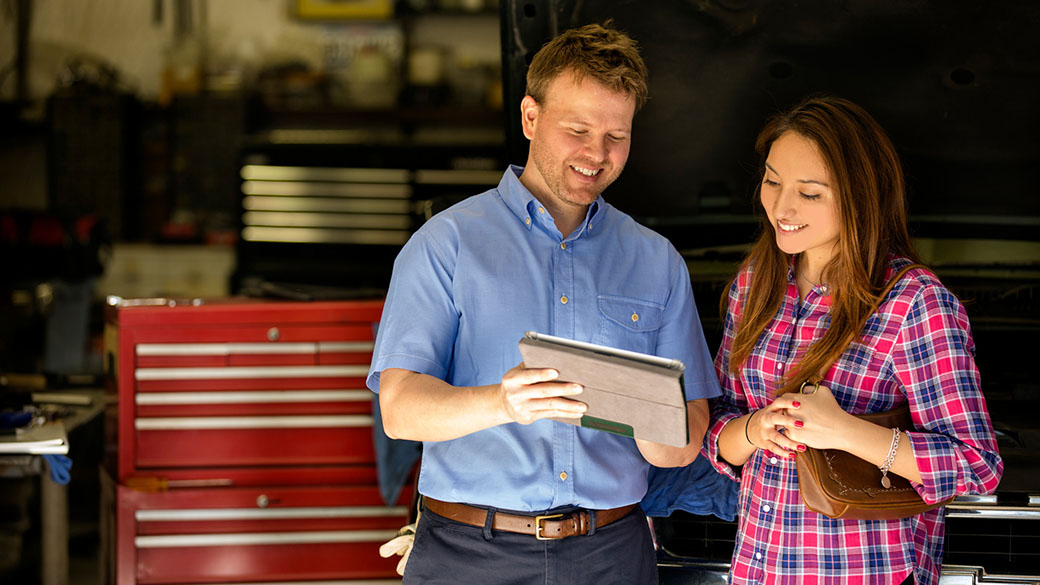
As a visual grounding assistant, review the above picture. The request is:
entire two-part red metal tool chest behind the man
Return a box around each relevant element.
[102,299,411,585]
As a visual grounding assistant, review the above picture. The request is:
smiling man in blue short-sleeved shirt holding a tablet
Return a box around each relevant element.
[368,20,719,585]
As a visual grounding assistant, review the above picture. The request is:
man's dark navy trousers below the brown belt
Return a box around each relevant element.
[402,506,657,585]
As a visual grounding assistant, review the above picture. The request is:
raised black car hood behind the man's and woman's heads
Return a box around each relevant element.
[502,0,1040,248]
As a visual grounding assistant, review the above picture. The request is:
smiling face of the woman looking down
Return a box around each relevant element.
[761,132,840,268]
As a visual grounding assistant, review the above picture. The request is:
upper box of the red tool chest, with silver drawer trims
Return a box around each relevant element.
[106,299,383,481]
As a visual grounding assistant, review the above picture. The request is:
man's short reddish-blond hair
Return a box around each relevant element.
[527,21,648,111]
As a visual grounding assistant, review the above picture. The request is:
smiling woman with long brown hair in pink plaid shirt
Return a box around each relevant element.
[705,97,1003,585]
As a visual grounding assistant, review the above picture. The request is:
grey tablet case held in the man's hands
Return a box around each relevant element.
[519,331,690,447]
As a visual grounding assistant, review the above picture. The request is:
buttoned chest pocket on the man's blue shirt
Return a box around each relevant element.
[593,295,665,354]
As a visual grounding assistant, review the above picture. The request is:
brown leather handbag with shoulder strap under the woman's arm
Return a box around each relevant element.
[796,264,953,520]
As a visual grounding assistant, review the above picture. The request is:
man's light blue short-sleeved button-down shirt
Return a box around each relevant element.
[367,167,720,511]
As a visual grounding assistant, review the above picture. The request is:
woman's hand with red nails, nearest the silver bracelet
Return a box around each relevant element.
[770,385,855,451]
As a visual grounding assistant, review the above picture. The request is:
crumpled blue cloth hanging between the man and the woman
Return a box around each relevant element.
[642,457,739,522]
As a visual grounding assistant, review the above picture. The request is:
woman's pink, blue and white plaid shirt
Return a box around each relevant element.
[705,258,1004,585]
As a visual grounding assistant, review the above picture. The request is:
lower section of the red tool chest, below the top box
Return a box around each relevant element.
[102,468,412,585]
